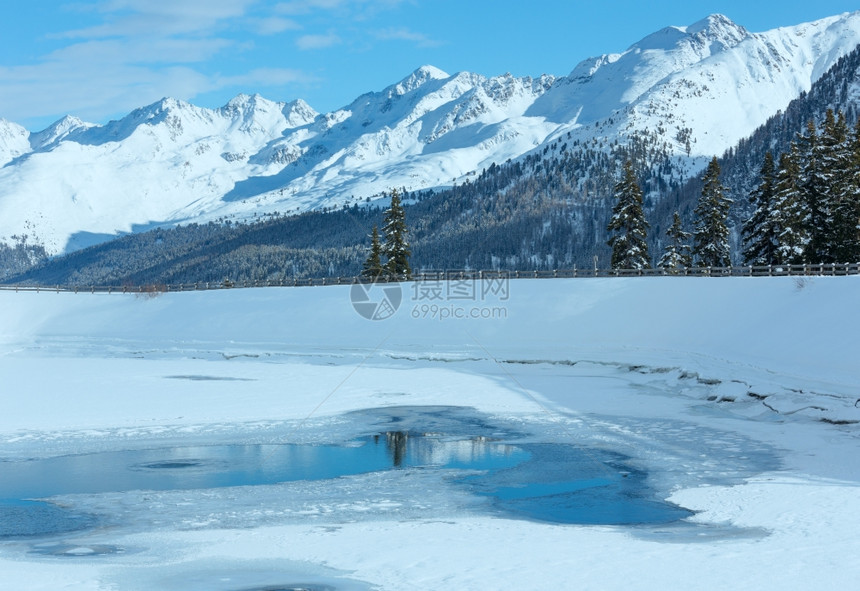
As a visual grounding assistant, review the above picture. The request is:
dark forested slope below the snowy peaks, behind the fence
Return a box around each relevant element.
[10,38,860,286]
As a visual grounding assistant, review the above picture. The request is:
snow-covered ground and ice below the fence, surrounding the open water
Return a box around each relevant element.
[0,277,860,591]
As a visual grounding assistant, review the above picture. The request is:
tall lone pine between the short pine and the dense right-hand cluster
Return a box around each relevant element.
[693,156,732,267]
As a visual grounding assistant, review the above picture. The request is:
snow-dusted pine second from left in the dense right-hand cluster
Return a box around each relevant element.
[773,143,809,265]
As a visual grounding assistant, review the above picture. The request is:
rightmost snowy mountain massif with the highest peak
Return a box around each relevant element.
[528,12,860,157]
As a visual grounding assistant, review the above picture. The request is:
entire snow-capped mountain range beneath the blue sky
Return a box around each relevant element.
[0,12,860,253]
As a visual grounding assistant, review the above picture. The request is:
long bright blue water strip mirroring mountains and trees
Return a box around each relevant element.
[0,432,528,499]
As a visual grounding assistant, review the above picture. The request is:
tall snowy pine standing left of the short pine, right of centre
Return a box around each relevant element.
[607,160,651,269]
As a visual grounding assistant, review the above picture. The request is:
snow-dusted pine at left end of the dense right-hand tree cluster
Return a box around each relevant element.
[743,152,779,265]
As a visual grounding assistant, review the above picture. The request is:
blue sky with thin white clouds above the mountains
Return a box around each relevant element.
[0,0,858,131]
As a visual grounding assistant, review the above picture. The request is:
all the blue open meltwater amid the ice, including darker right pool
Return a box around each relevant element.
[0,408,691,538]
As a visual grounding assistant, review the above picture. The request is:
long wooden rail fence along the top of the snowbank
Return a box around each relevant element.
[0,263,860,295]
